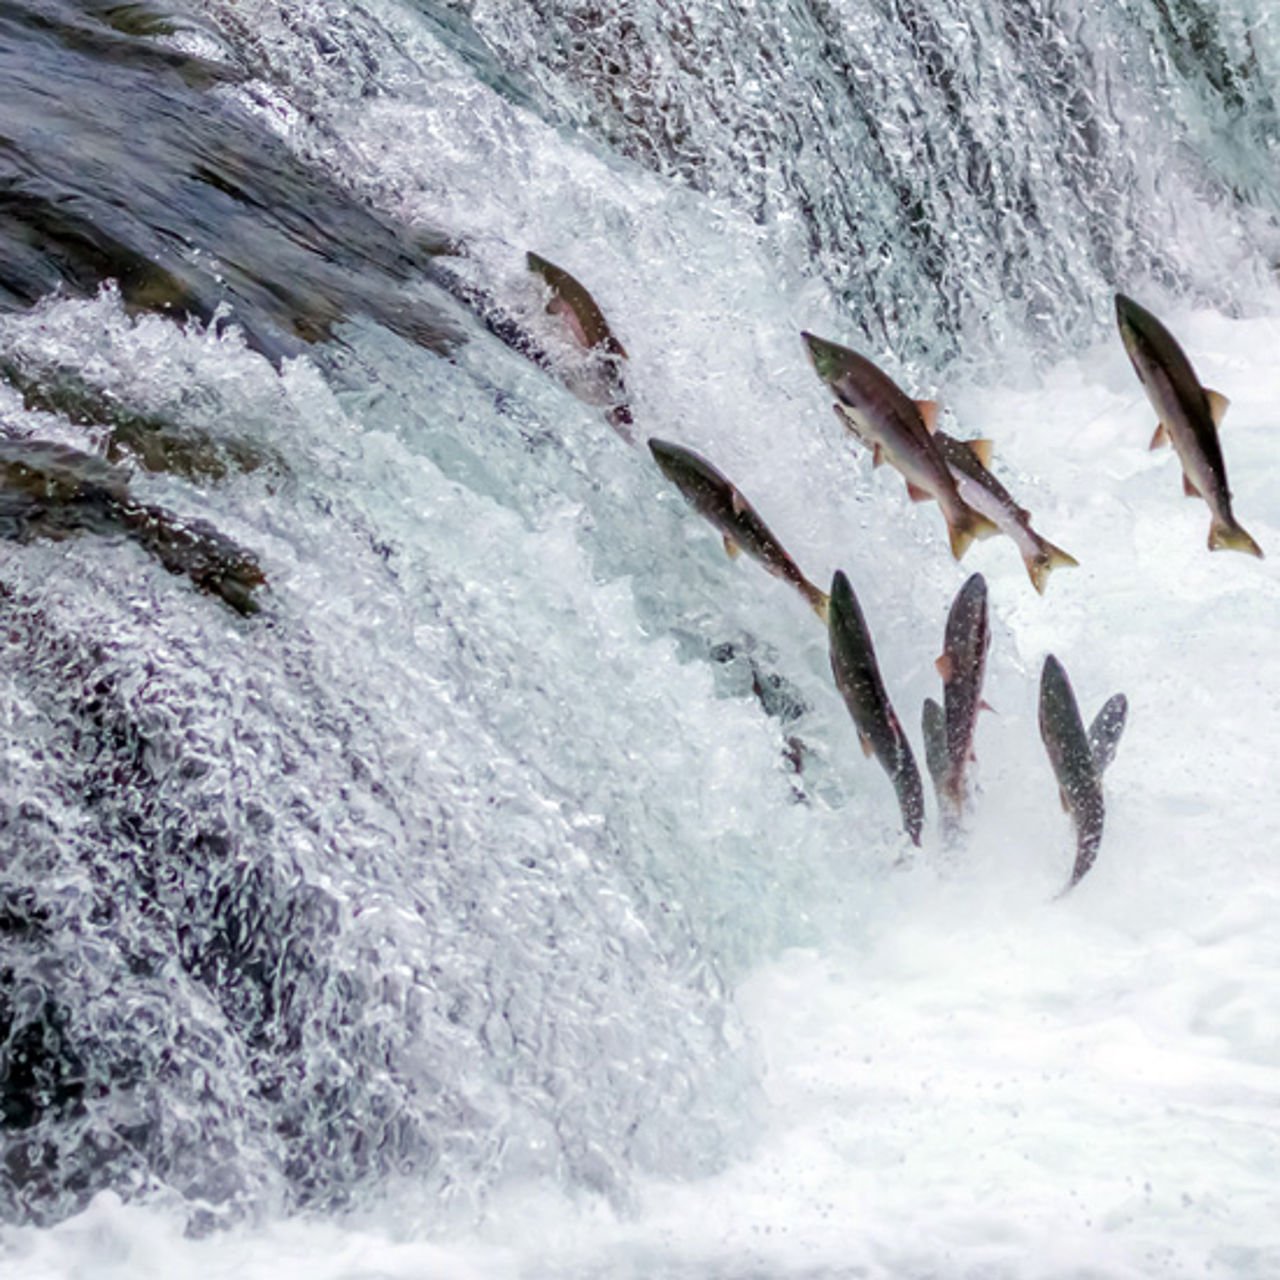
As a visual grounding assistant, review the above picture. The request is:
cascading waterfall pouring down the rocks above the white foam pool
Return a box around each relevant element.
[0,0,1280,1276]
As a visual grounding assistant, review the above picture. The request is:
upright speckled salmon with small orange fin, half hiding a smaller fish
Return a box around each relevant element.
[929,573,991,833]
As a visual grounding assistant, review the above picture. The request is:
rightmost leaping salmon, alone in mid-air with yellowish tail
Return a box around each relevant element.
[1116,293,1262,558]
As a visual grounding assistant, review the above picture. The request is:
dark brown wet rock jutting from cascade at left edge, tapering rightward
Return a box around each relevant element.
[0,439,266,614]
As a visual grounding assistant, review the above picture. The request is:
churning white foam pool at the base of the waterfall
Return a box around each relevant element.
[10,285,1280,1280]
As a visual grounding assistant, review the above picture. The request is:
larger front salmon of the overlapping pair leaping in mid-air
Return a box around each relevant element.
[800,333,998,559]
